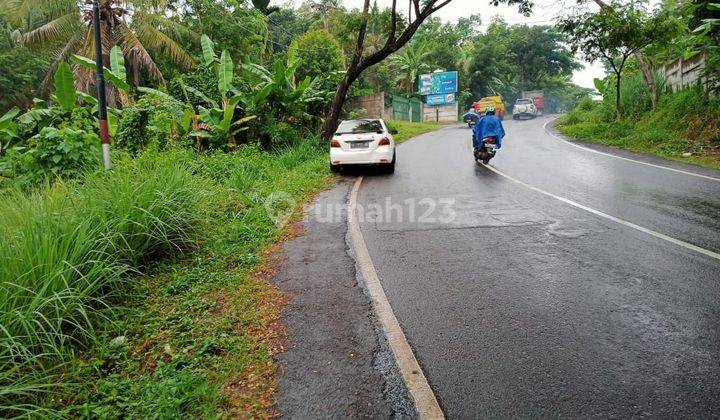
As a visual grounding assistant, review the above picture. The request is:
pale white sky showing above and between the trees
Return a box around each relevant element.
[310,0,604,88]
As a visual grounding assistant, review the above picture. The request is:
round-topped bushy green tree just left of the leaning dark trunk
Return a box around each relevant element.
[288,29,345,80]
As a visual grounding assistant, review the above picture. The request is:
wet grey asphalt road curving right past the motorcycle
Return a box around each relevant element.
[358,119,720,418]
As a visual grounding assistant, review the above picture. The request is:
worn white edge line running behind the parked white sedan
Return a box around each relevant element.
[348,176,445,420]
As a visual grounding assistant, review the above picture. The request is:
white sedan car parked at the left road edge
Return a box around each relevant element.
[330,119,397,173]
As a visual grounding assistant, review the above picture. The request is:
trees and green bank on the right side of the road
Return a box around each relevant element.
[557,1,720,169]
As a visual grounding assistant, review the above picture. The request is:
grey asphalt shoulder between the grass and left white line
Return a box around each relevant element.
[271,179,414,418]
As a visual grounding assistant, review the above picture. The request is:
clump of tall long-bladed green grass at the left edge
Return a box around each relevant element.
[0,149,208,417]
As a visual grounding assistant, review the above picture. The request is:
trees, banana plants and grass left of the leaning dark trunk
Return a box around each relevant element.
[0,1,464,418]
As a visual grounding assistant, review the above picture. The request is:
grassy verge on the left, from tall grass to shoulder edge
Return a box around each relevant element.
[0,139,330,418]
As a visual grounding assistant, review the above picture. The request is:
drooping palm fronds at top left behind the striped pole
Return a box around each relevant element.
[0,0,195,98]
